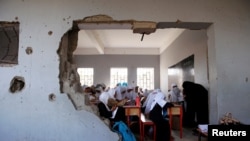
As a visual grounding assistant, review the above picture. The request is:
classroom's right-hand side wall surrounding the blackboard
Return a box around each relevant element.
[160,30,209,117]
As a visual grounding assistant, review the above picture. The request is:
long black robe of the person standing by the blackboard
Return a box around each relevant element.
[182,81,209,127]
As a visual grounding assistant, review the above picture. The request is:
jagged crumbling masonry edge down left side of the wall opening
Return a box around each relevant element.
[57,30,88,110]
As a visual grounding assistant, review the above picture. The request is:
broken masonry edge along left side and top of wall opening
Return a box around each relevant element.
[57,15,211,110]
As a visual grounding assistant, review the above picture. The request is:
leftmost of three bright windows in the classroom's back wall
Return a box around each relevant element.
[77,68,94,86]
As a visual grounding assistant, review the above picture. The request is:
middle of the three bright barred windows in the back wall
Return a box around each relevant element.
[110,68,128,87]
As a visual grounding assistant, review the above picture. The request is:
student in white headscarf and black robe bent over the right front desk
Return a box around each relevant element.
[146,89,173,141]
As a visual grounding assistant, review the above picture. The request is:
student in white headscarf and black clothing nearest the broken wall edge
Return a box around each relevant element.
[98,91,126,125]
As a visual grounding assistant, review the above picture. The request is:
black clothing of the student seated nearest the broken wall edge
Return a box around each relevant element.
[97,102,126,123]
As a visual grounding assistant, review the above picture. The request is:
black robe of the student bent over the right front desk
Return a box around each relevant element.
[149,103,172,141]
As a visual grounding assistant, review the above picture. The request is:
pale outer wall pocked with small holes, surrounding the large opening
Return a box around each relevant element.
[0,0,250,141]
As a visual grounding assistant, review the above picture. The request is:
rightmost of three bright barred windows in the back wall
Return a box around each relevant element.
[137,68,154,90]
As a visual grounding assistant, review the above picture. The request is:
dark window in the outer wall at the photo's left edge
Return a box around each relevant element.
[0,22,19,64]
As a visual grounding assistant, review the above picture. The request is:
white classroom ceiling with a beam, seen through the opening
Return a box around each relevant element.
[74,28,185,55]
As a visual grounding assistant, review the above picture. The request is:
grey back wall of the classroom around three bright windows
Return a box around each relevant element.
[74,55,160,88]
